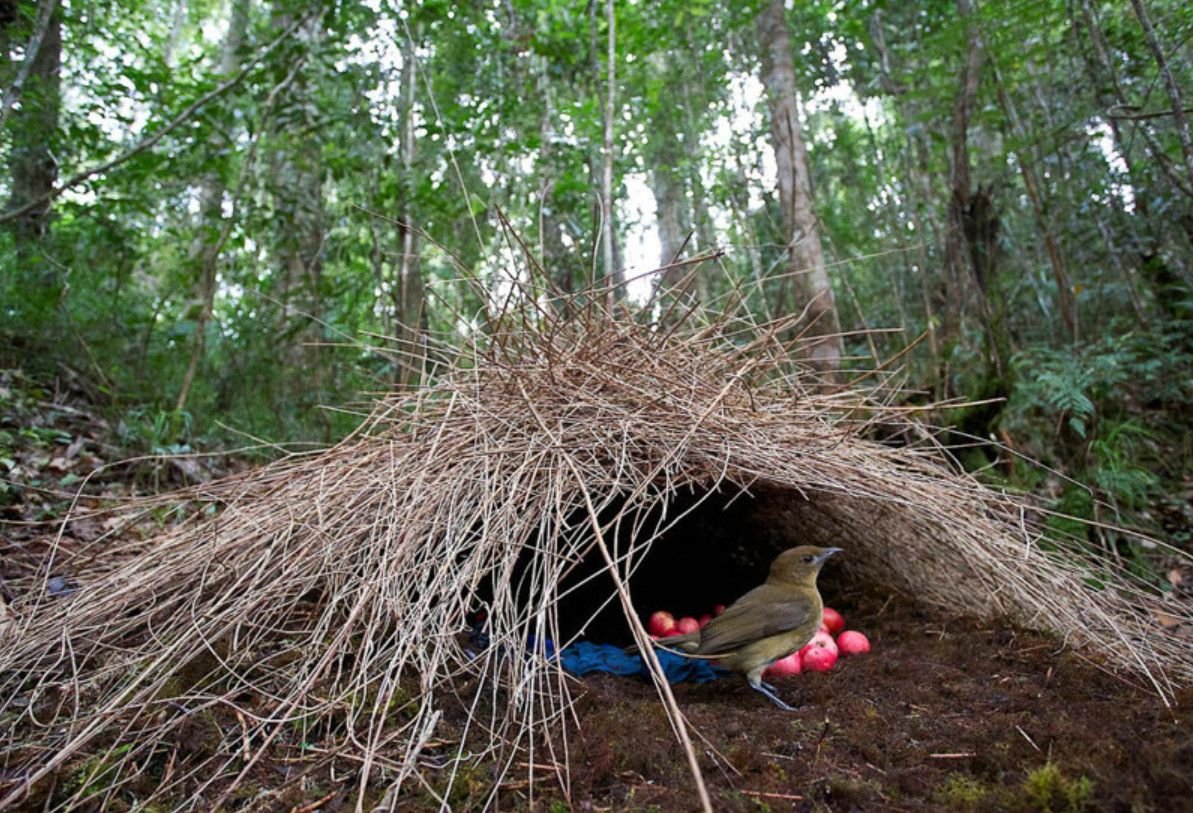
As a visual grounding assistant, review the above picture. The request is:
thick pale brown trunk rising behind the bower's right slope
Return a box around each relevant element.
[756,0,842,381]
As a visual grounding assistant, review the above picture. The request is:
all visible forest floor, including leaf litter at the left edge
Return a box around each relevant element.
[0,370,1193,813]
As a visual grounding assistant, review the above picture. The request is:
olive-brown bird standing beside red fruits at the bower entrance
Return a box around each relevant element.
[657,544,841,712]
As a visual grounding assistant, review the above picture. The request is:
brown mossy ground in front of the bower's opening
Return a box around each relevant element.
[502,596,1193,813]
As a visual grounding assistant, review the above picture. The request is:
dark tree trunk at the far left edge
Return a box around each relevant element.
[4,0,62,314]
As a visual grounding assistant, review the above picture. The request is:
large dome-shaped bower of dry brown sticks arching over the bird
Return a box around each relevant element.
[0,299,1193,807]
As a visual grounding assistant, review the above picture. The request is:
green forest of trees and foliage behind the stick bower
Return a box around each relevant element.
[0,0,1193,573]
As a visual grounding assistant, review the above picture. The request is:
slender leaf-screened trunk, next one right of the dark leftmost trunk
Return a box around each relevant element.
[174,0,252,412]
